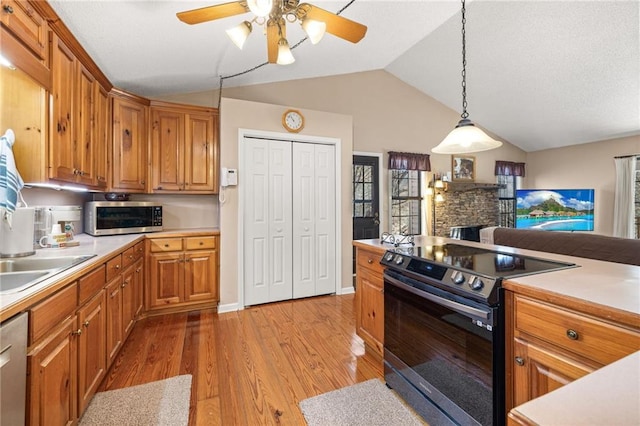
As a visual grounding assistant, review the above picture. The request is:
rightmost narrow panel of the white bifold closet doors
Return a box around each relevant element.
[313,145,337,295]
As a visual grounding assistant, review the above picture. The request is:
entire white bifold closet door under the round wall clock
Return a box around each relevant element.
[242,137,336,305]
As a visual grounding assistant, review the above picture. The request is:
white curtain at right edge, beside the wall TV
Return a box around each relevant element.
[613,156,636,238]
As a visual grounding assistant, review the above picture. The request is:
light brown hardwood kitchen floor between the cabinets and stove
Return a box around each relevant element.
[100,294,380,425]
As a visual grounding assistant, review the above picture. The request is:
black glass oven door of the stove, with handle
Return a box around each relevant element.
[384,270,504,425]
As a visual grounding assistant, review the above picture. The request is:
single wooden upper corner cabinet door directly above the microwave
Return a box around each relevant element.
[111,97,147,192]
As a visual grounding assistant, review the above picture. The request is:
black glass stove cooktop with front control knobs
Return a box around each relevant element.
[380,244,577,304]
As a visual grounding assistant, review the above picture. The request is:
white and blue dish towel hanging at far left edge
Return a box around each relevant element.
[0,129,24,227]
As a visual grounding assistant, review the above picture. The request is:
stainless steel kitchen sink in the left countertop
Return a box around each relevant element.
[0,254,95,294]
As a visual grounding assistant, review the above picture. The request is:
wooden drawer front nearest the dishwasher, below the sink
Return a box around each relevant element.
[29,281,78,345]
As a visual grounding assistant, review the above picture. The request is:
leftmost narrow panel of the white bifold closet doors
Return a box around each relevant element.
[243,139,269,305]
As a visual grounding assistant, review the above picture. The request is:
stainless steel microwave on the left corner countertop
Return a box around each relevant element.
[84,201,162,236]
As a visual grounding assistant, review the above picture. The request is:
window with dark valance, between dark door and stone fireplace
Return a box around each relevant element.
[390,170,422,235]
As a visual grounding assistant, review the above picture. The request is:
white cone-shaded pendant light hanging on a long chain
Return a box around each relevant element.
[431,0,502,154]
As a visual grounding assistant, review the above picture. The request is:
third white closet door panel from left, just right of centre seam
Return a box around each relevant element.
[293,143,316,298]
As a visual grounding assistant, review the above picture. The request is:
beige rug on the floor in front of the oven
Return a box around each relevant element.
[300,379,425,426]
